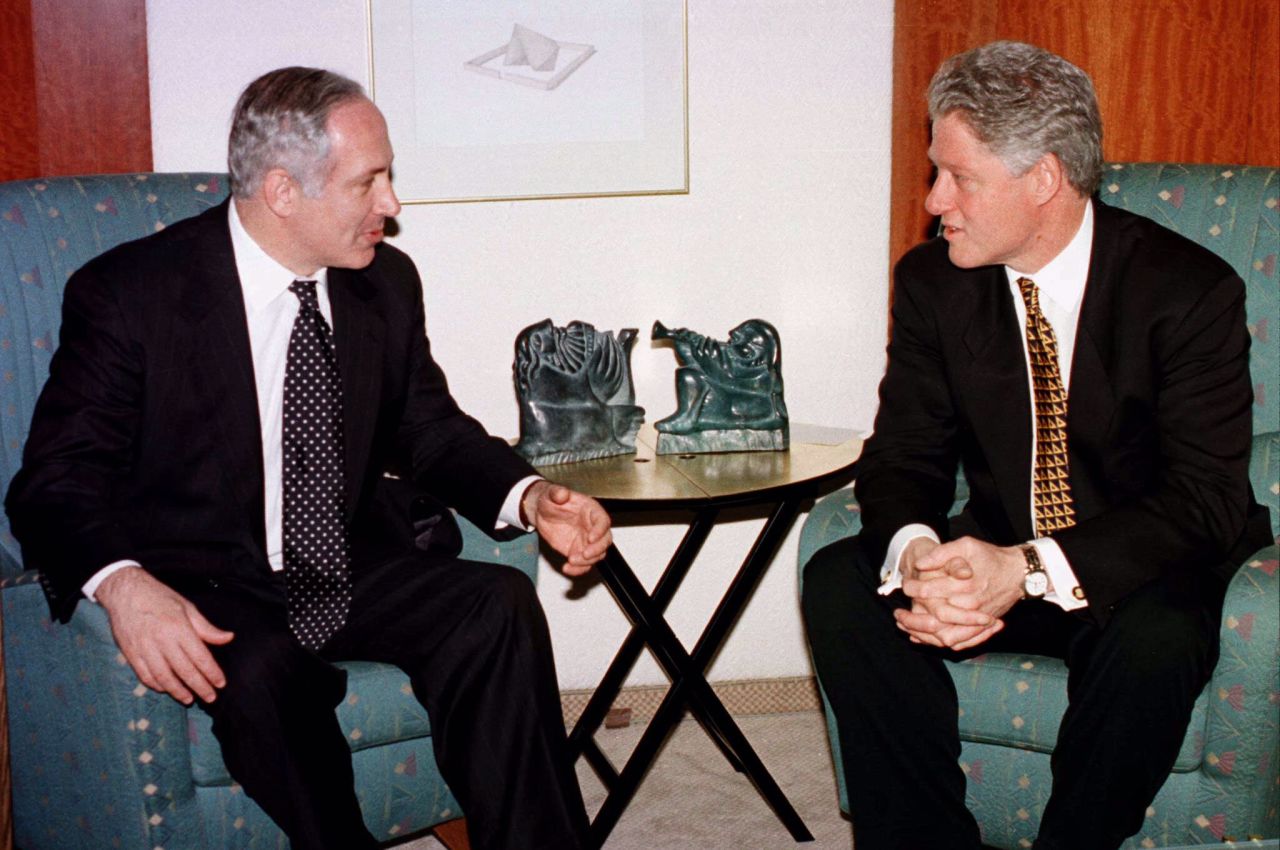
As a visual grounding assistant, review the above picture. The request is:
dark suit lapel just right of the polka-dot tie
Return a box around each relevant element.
[329,269,385,516]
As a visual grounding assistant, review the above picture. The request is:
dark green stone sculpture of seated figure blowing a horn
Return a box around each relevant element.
[653,319,790,454]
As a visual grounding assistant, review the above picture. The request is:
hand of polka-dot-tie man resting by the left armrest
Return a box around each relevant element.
[93,567,236,705]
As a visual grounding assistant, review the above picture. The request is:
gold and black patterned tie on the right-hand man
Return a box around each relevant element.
[1018,278,1075,538]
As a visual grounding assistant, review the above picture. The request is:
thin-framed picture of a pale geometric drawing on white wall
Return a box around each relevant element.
[367,0,689,204]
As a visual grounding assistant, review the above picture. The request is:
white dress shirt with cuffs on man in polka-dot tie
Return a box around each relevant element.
[83,202,539,593]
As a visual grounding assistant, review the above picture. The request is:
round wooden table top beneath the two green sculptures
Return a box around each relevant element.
[538,424,863,507]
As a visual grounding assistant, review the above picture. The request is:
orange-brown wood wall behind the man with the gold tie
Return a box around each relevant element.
[890,0,1280,272]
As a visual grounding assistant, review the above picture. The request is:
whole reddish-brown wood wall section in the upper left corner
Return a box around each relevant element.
[0,0,151,180]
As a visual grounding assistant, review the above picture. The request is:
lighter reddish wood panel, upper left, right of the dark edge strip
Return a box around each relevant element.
[31,0,151,175]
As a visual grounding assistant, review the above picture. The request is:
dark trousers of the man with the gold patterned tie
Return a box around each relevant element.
[803,538,1225,850]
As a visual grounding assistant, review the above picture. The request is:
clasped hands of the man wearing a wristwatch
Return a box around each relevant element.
[893,538,1025,650]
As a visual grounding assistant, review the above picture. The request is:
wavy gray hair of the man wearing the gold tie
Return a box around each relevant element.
[928,41,1102,197]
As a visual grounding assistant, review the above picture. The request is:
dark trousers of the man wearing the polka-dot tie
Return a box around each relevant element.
[182,557,588,850]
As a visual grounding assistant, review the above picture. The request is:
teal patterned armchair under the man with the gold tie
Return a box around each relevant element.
[799,163,1280,850]
